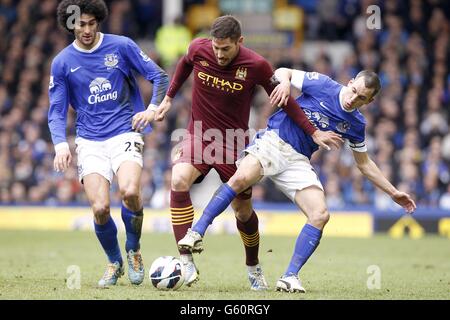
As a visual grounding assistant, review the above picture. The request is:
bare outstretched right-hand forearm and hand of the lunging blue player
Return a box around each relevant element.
[353,151,416,213]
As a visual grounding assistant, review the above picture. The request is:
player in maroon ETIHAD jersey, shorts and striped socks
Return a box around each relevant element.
[133,15,340,290]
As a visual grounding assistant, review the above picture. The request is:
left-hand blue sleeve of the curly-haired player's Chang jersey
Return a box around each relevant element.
[48,60,69,145]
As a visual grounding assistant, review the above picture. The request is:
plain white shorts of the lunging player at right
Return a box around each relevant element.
[243,131,323,202]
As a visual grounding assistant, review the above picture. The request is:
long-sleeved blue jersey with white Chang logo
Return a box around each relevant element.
[48,33,168,145]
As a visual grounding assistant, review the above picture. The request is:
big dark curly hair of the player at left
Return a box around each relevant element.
[56,0,108,33]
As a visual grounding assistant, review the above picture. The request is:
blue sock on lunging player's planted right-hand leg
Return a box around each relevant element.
[285,224,322,275]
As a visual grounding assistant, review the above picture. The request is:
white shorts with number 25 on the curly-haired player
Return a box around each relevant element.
[75,132,144,184]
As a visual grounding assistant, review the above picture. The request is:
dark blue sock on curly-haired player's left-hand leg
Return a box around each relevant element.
[94,217,123,265]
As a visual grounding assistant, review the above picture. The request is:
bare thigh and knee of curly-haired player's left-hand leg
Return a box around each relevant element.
[83,173,110,212]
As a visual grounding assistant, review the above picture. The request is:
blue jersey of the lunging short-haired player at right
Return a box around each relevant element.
[267,70,367,158]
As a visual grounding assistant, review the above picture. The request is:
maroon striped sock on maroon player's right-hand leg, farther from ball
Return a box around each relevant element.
[236,211,259,266]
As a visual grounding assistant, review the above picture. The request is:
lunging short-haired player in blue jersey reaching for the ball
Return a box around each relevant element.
[178,68,416,292]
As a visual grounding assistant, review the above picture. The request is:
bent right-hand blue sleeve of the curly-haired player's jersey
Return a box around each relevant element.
[124,38,169,105]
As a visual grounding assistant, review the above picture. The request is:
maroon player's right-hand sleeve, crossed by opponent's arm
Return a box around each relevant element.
[258,60,317,135]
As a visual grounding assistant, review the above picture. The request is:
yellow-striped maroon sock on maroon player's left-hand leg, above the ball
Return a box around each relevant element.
[170,190,194,254]
